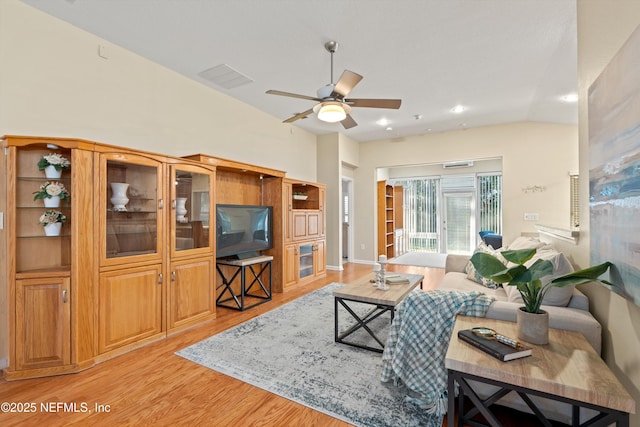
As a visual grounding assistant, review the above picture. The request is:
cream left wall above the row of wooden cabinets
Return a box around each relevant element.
[0,0,316,181]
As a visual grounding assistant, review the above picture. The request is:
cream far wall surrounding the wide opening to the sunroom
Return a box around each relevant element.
[354,123,578,261]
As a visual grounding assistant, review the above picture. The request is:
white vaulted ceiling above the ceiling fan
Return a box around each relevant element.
[22,0,578,141]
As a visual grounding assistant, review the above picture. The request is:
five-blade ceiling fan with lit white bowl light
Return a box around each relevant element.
[267,41,402,129]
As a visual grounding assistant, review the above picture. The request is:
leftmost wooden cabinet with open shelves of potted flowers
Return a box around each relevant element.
[0,136,95,380]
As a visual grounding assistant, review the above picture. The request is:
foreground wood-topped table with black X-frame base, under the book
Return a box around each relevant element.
[445,316,635,427]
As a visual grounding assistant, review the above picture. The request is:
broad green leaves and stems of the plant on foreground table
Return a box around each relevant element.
[471,249,615,314]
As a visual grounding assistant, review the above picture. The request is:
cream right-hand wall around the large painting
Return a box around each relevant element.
[567,0,640,426]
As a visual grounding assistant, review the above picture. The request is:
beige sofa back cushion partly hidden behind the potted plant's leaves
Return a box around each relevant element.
[504,246,574,307]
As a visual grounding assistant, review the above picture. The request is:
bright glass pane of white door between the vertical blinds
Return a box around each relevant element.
[441,191,475,254]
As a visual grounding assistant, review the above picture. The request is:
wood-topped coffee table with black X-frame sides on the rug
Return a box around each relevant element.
[333,273,424,353]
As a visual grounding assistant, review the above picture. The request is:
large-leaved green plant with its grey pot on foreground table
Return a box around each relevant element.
[471,249,615,344]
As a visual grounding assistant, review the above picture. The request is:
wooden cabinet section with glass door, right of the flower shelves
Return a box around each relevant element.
[95,151,166,355]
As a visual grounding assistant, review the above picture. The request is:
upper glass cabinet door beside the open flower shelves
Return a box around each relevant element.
[102,155,163,260]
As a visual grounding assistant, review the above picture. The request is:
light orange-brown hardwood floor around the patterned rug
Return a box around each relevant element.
[0,264,552,427]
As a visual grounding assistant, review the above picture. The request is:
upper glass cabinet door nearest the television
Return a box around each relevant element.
[171,165,213,252]
